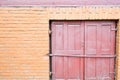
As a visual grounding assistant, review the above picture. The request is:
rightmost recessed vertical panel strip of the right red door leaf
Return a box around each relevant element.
[100,22,111,79]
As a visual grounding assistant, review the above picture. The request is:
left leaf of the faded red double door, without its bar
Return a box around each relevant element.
[52,21,84,80]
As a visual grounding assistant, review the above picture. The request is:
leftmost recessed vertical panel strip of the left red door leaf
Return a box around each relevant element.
[55,23,64,79]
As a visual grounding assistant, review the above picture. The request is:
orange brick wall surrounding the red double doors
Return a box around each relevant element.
[0,6,120,80]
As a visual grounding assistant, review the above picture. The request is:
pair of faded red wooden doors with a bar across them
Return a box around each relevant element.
[51,21,115,80]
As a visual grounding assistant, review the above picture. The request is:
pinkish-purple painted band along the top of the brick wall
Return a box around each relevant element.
[0,0,120,6]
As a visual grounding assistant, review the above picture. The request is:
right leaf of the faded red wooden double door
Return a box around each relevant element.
[85,21,115,80]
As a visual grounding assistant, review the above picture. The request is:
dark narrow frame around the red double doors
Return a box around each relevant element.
[48,20,119,80]
